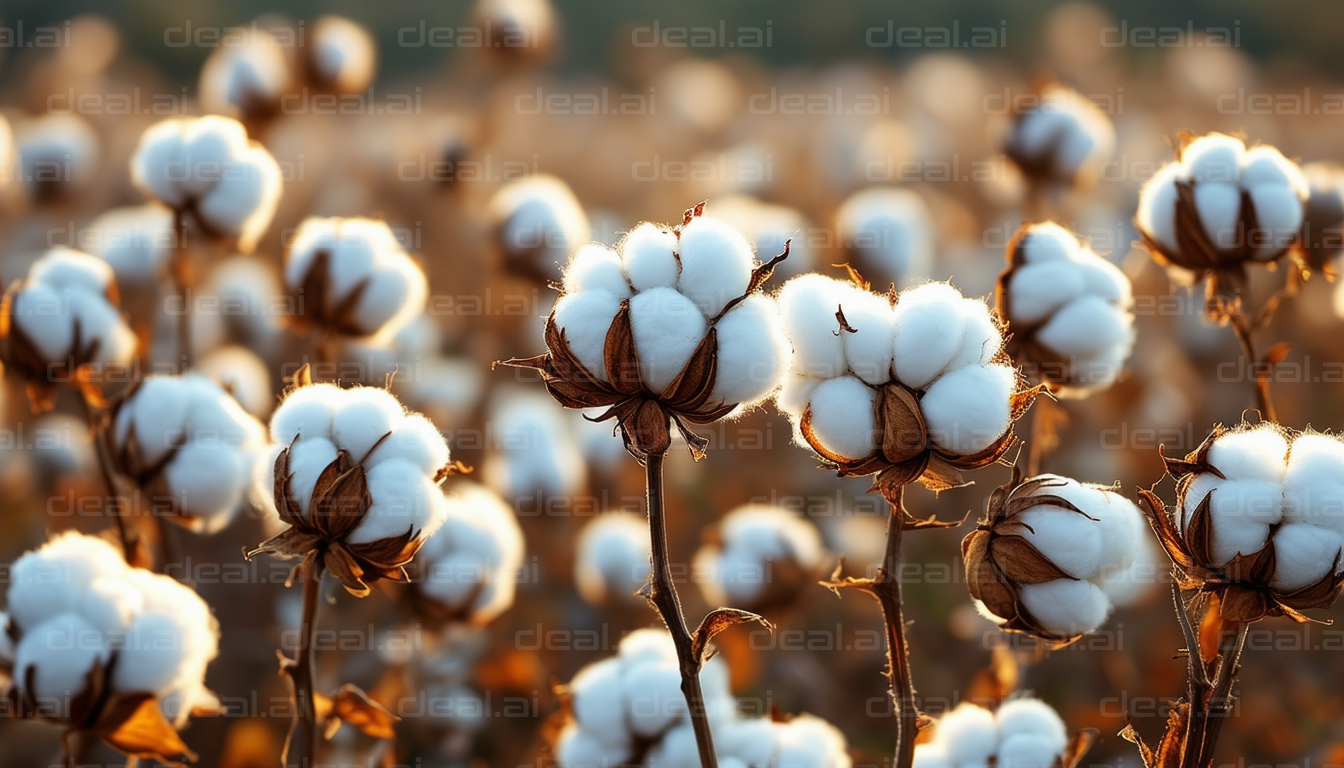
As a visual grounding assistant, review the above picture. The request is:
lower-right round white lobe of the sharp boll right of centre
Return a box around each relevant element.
[924,366,1016,456]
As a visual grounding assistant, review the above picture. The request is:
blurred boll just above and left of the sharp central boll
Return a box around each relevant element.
[487,175,593,281]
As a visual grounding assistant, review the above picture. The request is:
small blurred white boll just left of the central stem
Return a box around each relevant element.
[574,514,650,605]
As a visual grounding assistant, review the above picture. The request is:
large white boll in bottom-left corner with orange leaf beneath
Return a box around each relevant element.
[0,531,219,765]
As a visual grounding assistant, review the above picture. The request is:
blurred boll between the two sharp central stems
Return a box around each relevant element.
[695,504,825,613]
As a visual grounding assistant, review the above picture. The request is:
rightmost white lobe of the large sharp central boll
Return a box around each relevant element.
[710,295,792,404]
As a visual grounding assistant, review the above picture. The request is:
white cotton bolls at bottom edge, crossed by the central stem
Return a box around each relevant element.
[555,629,851,768]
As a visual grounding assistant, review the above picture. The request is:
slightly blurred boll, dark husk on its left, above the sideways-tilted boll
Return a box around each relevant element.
[995,222,1134,397]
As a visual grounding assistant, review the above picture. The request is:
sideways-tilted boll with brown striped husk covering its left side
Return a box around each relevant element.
[961,475,1144,646]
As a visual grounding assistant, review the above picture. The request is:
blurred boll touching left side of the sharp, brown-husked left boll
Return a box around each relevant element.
[109,374,269,533]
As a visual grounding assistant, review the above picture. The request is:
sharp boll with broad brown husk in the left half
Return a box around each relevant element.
[247,366,452,597]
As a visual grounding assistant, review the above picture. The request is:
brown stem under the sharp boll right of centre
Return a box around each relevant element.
[872,486,919,768]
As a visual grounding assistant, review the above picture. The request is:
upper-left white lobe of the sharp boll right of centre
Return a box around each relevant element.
[778,274,848,379]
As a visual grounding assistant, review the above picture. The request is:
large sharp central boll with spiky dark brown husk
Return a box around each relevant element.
[509,206,789,461]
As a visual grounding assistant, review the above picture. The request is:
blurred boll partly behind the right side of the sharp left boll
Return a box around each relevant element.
[417,482,523,624]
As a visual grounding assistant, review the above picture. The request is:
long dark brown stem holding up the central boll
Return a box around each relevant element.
[644,453,719,768]
